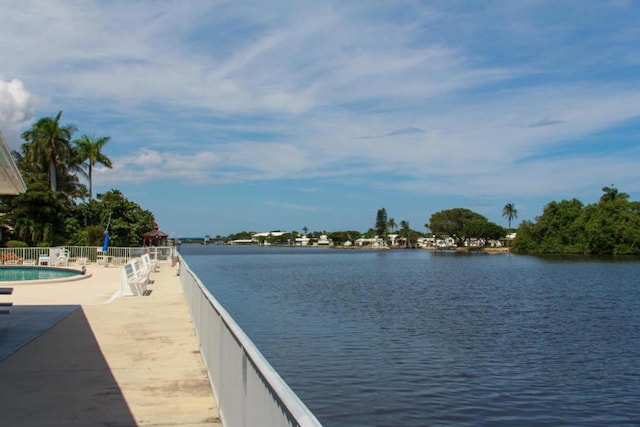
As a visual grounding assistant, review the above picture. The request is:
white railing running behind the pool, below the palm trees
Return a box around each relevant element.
[0,246,175,266]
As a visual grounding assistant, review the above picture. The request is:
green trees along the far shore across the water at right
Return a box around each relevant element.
[370,185,640,255]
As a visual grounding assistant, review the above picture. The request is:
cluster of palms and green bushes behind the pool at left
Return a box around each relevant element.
[0,111,155,246]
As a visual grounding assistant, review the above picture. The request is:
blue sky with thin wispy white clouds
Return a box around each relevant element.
[0,0,640,236]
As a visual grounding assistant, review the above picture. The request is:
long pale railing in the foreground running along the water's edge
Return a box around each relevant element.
[178,254,321,427]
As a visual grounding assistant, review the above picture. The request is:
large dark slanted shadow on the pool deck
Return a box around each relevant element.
[0,306,136,427]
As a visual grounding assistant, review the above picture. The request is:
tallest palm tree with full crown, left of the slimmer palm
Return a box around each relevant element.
[22,111,76,191]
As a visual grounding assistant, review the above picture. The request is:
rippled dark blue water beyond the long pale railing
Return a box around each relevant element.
[181,246,640,426]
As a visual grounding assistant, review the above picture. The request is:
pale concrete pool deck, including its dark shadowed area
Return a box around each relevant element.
[0,264,222,427]
